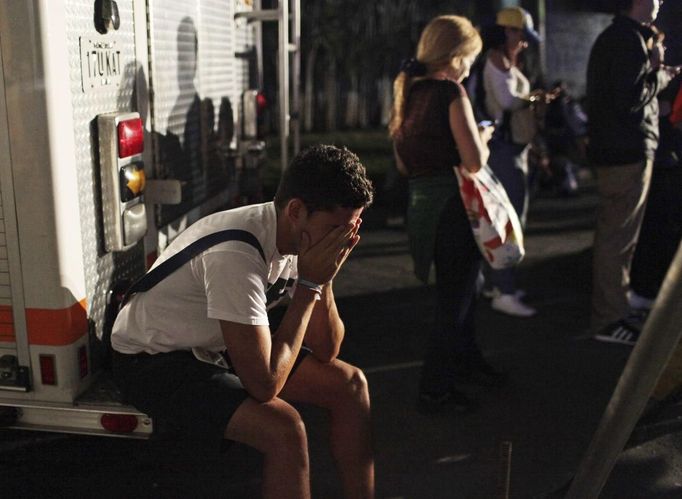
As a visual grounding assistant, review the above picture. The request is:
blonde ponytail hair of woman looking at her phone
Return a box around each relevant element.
[388,16,483,137]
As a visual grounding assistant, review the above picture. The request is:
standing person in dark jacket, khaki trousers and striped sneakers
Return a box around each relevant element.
[587,0,679,345]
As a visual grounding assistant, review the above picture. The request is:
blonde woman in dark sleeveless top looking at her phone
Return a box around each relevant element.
[389,16,503,412]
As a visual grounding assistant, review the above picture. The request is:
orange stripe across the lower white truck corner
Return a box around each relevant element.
[0,300,88,346]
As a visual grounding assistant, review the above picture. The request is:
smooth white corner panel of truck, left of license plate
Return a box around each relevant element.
[0,0,85,309]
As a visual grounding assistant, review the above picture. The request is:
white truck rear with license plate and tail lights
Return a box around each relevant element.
[0,0,297,437]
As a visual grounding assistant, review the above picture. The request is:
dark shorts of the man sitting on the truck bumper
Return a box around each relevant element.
[113,347,310,452]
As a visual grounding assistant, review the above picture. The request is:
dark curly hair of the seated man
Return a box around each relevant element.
[275,144,374,213]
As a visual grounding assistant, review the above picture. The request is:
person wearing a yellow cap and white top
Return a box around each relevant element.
[483,7,545,317]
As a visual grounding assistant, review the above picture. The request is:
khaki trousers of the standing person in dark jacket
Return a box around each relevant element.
[591,160,653,333]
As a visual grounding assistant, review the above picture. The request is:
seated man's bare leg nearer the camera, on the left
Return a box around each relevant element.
[225,398,310,499]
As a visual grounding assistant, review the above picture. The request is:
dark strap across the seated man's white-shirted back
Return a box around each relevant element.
[119,229,266,309]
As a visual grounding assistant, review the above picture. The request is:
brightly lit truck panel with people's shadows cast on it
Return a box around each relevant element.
[149,0,253,225]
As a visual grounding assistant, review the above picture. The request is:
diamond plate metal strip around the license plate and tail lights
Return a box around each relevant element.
[66,0,145,338]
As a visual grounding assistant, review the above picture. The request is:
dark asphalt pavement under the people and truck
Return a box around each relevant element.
[0,181,682,499]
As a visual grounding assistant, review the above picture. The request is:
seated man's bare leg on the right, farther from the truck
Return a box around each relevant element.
[280,355,374,499]
